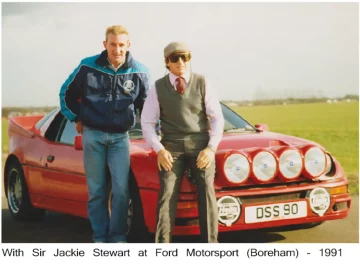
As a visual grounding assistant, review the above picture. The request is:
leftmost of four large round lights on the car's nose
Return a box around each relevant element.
[224,154,250,183]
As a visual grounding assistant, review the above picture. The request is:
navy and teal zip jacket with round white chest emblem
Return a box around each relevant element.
[59,50,150,133]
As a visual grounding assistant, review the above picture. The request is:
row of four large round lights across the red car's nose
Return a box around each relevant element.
[224,147,332,184]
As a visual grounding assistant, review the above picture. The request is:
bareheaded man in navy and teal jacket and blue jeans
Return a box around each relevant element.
[59,25,150,243]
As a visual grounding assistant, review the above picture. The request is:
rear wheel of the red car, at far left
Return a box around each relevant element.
[6,163,46,221]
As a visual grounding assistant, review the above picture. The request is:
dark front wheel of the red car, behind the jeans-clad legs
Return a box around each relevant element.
[108,176,152,243]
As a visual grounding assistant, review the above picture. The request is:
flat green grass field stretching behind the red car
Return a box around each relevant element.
[2,102,359,193]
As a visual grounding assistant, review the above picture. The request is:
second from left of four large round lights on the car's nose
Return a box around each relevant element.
[253,151,277,182]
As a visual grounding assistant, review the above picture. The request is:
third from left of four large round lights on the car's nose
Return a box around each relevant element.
[279,149,303,179]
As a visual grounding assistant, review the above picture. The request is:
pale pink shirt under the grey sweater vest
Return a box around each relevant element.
[141,72,224,153]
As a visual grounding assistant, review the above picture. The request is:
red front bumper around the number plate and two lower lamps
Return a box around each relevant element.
[140,178,351,235]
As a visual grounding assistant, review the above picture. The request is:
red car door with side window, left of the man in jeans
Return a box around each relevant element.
[42,113,88,205]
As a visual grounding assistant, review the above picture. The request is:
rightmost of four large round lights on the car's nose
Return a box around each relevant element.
[305,147,326,177]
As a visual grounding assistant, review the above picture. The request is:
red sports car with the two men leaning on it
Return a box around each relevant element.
[4,105,351,240]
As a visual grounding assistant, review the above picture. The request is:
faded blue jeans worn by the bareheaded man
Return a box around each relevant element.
[82,127,130,243]
